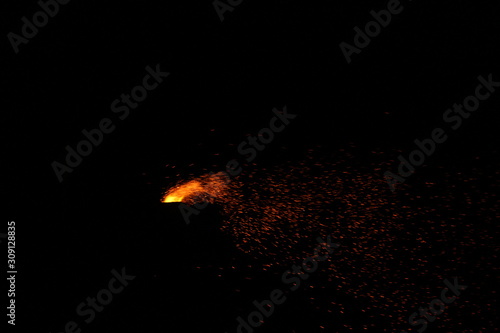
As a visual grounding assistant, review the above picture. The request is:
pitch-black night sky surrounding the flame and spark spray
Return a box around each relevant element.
[0,0,500,332]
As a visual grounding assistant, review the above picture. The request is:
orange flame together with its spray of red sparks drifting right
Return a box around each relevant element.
[164,147,500,332]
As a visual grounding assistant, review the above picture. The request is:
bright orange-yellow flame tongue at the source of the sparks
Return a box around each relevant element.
[162,172,229,204]
